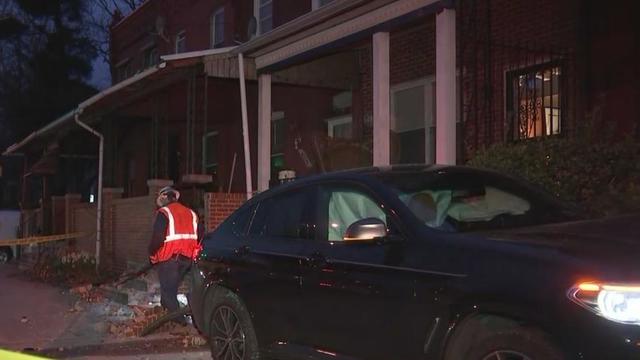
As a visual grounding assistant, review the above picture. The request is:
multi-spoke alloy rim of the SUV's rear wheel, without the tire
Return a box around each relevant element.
[211,305,246,360]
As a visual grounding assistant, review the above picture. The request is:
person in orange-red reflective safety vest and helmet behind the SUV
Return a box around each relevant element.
[149,186,200,322]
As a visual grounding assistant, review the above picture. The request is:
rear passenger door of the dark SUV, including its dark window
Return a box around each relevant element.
[236,188,315,348]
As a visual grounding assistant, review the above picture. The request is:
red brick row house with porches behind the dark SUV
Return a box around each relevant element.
[5,0,640,267]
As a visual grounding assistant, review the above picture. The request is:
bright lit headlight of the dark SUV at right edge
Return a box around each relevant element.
[568,282,640,325]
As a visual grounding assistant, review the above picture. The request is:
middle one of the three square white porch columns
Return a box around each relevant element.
[373,32,390,166]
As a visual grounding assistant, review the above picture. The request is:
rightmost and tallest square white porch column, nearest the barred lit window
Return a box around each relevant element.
[436,9,456,165]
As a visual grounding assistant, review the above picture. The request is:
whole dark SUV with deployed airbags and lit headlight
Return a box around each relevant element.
[191,166,640,360]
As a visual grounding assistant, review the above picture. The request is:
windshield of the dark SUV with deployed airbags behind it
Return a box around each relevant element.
[378,170,578,232]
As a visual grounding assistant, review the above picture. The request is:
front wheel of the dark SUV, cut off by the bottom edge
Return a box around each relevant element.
[445,316,565,360]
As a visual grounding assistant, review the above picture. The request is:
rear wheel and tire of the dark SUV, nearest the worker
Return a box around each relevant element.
[209,287,261,360]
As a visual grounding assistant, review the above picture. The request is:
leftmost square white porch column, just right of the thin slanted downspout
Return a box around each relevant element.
[258,74,271,191]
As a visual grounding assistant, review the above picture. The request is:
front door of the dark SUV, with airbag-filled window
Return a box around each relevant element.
[303,185,427,360]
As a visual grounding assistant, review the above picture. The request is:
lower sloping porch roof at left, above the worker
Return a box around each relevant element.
[2,47,245,156]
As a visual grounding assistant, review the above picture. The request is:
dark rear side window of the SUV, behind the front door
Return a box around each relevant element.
[250,188,315,239]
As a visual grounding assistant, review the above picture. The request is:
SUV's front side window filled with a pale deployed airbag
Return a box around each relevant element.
[324,188,388,241]
